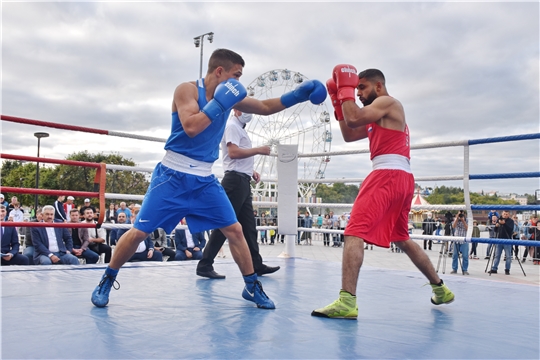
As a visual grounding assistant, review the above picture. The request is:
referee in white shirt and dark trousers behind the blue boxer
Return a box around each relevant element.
[197,110,279,279]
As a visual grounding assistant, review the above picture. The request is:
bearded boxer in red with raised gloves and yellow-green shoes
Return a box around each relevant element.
[311,65,454,320]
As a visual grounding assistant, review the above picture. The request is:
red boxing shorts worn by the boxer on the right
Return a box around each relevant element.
[345,169,414,248]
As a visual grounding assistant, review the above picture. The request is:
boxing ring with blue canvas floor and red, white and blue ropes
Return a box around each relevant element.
[0,115,540,359]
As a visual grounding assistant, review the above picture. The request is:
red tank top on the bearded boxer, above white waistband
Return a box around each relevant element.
[366,123,411,160]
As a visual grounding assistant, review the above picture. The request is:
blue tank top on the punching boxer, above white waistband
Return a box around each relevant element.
[165,79,231,163]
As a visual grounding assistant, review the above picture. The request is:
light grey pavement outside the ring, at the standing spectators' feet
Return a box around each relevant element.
[216,239,540,286]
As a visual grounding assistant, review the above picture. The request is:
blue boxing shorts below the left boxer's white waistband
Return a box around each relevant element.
[133,163,237,234]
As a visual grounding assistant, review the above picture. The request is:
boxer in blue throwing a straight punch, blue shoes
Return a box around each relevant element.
[92,49,326,309]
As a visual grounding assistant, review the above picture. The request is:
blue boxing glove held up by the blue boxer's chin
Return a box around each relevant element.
[201,78,247,122]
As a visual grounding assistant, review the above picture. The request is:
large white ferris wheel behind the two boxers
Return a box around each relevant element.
[242,69,332,199]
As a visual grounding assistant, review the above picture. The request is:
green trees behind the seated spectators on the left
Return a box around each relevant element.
[0,151,149,206]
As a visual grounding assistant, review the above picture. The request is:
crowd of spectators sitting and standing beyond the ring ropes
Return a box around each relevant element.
[0,194,540,268]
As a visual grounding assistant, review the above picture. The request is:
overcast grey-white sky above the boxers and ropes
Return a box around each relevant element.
[1,2,540,194]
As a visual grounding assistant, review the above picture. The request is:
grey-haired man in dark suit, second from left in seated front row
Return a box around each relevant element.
[32,205,79,265]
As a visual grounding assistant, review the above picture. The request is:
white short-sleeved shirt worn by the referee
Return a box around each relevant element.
[221,116,254,177]
